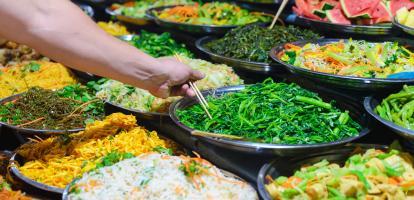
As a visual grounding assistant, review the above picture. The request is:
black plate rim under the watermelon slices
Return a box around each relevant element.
[294,15,393,36]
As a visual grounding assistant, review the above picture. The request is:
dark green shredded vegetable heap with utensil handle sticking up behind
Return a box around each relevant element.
[206,25,320,63]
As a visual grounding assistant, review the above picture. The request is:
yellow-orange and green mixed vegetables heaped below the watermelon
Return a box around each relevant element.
[277,39,414,78]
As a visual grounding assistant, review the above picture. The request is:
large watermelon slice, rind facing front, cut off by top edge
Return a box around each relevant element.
[339,0,381,18]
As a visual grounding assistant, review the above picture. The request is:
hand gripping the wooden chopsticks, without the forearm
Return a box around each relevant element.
[145,57,204,98]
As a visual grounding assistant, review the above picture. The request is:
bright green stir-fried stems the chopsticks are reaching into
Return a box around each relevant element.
[177,79,361,144]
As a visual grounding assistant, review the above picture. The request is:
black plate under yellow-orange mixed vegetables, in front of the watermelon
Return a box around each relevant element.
[270,39,414,91]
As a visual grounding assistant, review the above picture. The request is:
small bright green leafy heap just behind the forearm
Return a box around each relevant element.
[129,31,194,58]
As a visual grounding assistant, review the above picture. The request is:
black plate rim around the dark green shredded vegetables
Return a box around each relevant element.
[196,36,284,73]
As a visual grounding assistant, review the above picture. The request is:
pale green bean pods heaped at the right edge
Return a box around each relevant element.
[375,85,414,130]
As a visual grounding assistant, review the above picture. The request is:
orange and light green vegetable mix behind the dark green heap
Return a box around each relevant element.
[154,2,272,26]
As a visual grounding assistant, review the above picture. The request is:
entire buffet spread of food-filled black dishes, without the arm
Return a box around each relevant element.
[0,0,414,200]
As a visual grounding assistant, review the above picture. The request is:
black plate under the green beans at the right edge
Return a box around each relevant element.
[364,91,414,140]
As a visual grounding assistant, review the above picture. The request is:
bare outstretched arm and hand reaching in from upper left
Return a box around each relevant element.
[0,0,203,98]
